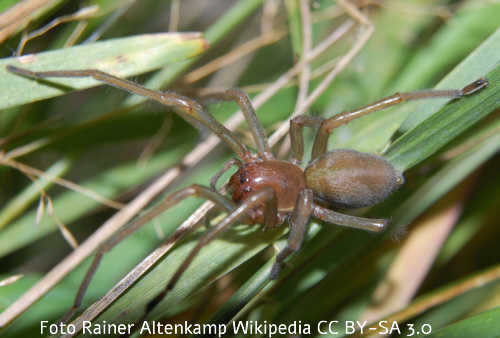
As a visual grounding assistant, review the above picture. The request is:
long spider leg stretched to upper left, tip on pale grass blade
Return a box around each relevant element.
[7,65,252,160]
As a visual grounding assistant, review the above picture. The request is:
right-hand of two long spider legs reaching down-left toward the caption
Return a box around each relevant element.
[134,188,277,328]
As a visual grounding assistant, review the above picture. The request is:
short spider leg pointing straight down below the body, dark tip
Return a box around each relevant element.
[269,189,314,279]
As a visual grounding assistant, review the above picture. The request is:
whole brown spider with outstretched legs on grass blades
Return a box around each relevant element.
[7,65,488,328]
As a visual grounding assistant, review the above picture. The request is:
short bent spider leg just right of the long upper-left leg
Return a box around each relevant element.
[203,88,274,160]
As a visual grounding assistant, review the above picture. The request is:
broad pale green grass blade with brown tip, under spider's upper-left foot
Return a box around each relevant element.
[0,33,207,109]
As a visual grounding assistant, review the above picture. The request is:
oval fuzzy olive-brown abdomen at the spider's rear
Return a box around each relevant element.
[305,149,404,208]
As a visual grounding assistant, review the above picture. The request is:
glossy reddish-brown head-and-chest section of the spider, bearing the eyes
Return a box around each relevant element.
[229,160,306,212]
